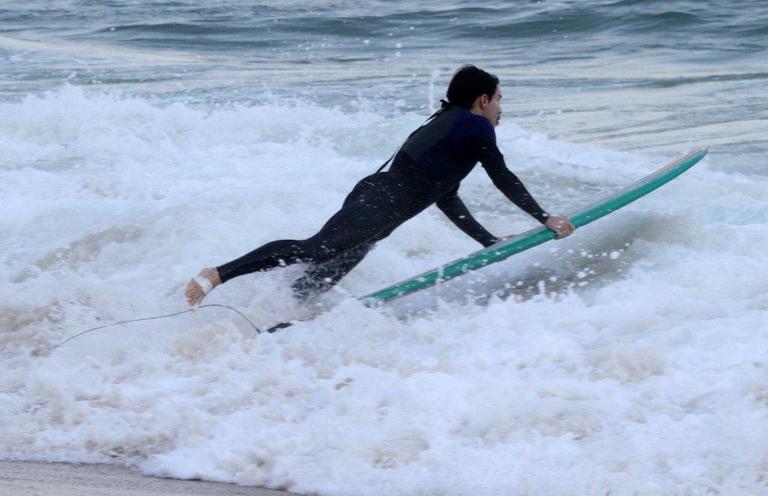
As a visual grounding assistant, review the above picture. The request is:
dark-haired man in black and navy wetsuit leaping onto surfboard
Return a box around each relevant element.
[185,65,574,305]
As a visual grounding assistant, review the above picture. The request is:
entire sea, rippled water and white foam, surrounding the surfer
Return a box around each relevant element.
[0,0,768,496]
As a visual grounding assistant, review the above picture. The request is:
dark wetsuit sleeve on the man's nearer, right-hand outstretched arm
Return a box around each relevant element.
[479,131,549,224]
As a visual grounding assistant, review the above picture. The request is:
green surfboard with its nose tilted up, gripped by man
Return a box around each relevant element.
[360,149,708,306]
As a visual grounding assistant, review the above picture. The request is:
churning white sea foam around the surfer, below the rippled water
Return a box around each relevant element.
[0,87,768,495]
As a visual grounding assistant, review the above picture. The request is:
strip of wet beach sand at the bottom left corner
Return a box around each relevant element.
[0,461,300,496]
